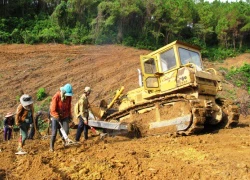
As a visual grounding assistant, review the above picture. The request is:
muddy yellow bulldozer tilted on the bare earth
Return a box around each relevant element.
[89,41,239,136]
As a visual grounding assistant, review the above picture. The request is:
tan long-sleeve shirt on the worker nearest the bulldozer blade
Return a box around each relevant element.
[74,94,89,118]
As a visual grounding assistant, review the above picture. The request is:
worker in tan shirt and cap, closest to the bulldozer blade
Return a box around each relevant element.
[74,87,91,141]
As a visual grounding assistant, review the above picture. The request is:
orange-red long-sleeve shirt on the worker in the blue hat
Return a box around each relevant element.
[50,91,72,119]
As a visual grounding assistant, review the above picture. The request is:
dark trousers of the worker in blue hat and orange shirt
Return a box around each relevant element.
[50,117,69,149]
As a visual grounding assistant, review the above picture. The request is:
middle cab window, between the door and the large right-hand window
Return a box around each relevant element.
[160,48,176,72]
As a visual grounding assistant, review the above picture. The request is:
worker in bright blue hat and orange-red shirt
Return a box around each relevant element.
[50,84,73,152]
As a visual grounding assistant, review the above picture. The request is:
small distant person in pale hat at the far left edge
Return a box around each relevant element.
[3,112,15,141]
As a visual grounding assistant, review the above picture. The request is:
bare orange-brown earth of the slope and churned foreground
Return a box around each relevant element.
[0,44,250,180]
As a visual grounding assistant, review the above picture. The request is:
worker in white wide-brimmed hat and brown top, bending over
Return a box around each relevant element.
[15,94,34,152]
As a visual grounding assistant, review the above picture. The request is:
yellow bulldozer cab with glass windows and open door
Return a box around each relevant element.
[140,41,202,92]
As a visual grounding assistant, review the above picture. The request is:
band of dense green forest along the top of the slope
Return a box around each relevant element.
[0,0,250,59]
